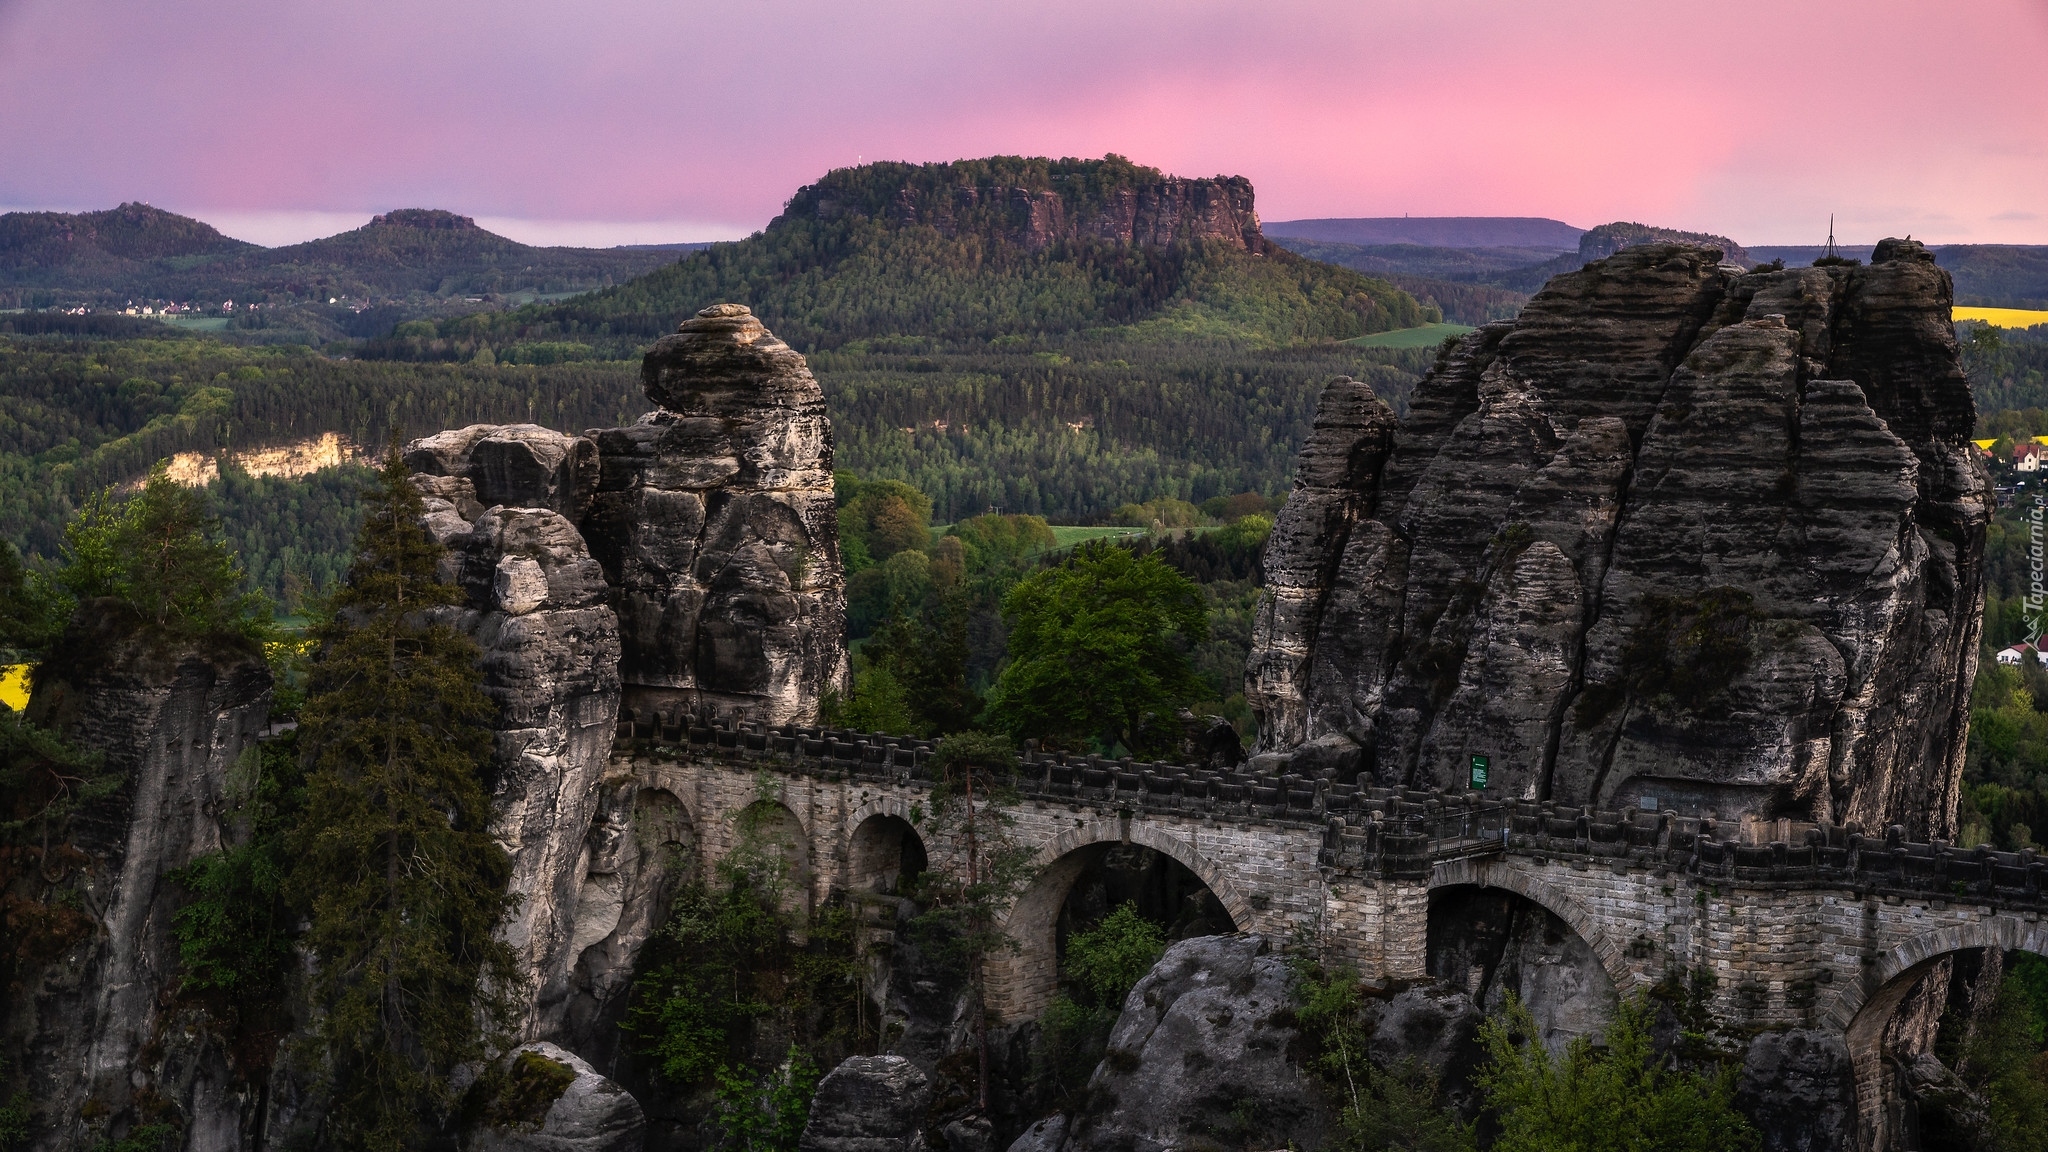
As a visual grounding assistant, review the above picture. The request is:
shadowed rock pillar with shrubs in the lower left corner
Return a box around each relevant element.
[6,619,270,1152]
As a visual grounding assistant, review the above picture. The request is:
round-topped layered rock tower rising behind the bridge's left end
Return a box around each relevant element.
[584,303,846,724]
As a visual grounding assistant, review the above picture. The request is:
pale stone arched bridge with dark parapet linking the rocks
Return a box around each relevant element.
[612,722,2048,1148]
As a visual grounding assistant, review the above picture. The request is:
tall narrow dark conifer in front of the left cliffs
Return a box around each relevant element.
[293,449,518,1150]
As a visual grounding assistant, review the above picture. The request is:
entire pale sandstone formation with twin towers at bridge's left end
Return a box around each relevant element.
[406,305,846,1050]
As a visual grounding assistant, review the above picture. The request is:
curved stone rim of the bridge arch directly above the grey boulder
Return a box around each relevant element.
[983,820,1255,1021]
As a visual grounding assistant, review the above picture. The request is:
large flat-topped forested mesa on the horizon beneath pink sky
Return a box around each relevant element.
[391,156,1438,359]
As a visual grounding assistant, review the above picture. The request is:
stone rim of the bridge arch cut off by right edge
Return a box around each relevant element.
[1829,916,2048,1152]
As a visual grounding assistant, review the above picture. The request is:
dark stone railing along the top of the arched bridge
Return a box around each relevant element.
[618,715,2048,908]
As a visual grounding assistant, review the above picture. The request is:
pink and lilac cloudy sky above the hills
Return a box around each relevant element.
[0,0,2048,244]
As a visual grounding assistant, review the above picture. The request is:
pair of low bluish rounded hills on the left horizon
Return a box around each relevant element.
[0,203,676,323]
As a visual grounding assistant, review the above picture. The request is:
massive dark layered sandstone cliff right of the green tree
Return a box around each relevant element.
[1247,240,1991,836]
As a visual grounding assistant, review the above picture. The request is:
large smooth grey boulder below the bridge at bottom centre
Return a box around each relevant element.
[1065,935,1327,1152]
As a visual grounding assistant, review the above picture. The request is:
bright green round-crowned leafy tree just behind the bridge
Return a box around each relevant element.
[989,545,1208,754]
